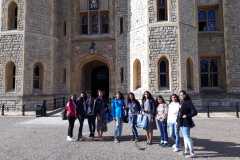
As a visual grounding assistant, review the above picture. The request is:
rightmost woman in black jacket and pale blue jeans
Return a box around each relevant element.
[177,90,197,157]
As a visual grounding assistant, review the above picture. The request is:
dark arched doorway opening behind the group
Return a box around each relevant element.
[80,60,109,97]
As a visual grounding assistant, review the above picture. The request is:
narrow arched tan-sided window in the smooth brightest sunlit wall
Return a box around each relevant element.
[133,59,141,90]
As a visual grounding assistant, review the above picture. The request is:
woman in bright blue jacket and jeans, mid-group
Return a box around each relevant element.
[112,92,125,143]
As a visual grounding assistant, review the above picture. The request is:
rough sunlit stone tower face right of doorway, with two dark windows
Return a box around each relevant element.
[148,0,179,94]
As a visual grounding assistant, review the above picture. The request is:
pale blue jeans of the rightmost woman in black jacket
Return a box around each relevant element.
[180,127,193,153]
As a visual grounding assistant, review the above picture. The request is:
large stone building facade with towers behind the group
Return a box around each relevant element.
[0,0,240,109]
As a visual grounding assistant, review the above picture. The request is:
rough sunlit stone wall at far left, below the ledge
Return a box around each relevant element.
[0,31,24,96]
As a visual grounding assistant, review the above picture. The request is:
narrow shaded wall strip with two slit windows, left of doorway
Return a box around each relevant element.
[53,0,71,94]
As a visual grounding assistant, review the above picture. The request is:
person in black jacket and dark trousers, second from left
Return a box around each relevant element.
[76,92,87,141]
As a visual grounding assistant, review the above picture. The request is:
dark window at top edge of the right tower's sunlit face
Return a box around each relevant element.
[157,0,168,21]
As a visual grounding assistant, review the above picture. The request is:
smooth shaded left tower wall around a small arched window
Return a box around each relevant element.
[24,0,56,96]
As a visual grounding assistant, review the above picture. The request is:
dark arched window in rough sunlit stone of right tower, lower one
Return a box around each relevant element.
[159,57,169,89]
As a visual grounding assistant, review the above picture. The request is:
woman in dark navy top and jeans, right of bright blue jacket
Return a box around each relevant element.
[126,92,141,142]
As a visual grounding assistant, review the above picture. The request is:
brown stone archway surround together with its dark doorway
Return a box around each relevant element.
[70,54,115,96]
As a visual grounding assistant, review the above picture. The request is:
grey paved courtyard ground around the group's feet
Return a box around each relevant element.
[0,116,240,160]
